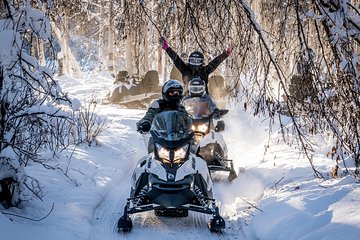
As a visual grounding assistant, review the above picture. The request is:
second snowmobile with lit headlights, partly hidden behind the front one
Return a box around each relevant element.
[183,95,237,181]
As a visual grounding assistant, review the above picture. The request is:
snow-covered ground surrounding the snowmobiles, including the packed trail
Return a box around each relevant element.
[0,76,360,240]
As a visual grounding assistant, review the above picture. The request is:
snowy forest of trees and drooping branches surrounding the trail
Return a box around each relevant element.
[0,0,360,226]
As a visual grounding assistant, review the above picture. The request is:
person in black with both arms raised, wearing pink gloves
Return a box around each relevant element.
[160,37,233,93]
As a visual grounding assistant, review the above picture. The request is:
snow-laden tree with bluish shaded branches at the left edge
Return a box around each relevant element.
[0,1,72,207]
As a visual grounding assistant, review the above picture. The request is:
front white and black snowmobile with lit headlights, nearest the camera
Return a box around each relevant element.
[118,111,225,232]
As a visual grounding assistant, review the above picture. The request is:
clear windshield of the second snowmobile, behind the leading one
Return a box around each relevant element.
[183,97,215,119]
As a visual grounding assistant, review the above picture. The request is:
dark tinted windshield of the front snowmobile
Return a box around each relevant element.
[150,111,192,148]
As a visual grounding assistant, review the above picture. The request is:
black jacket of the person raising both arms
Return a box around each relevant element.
[166,47,228,93]
